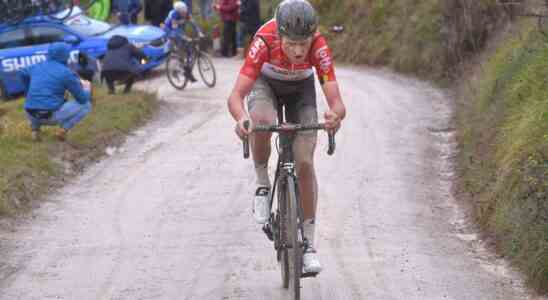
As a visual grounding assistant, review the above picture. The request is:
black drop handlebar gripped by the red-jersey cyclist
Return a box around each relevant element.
[243,121,336,159]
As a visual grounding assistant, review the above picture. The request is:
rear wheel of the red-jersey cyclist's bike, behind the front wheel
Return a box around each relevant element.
[278,180,290,289]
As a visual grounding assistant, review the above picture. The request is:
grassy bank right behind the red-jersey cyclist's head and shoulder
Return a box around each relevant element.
[306,0,446,78]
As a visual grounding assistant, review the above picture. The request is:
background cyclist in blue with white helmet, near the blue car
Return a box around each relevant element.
[164,1,204,82]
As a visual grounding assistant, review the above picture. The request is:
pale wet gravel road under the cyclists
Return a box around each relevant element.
[0,59,536,300]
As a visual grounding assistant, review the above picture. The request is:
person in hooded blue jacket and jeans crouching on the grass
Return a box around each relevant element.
[21,42,91,141]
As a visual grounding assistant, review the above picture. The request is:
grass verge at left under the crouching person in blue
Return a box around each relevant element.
[0,89,156,215]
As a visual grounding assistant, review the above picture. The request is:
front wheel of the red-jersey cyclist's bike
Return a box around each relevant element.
[287,176,303,300]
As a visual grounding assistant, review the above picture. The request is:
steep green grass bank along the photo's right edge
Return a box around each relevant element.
[459,23,548,293]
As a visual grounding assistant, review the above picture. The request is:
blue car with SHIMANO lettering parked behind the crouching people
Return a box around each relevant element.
[0,7,169,99]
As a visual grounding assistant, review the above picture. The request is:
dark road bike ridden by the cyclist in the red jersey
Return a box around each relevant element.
[243,103,335,300]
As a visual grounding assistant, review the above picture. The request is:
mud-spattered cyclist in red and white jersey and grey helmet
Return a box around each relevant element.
[228,0,346,273]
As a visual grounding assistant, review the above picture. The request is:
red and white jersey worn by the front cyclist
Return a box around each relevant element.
[240,19,336,84]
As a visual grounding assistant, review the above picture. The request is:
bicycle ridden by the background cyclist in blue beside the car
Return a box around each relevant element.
[166,37,217,90]
